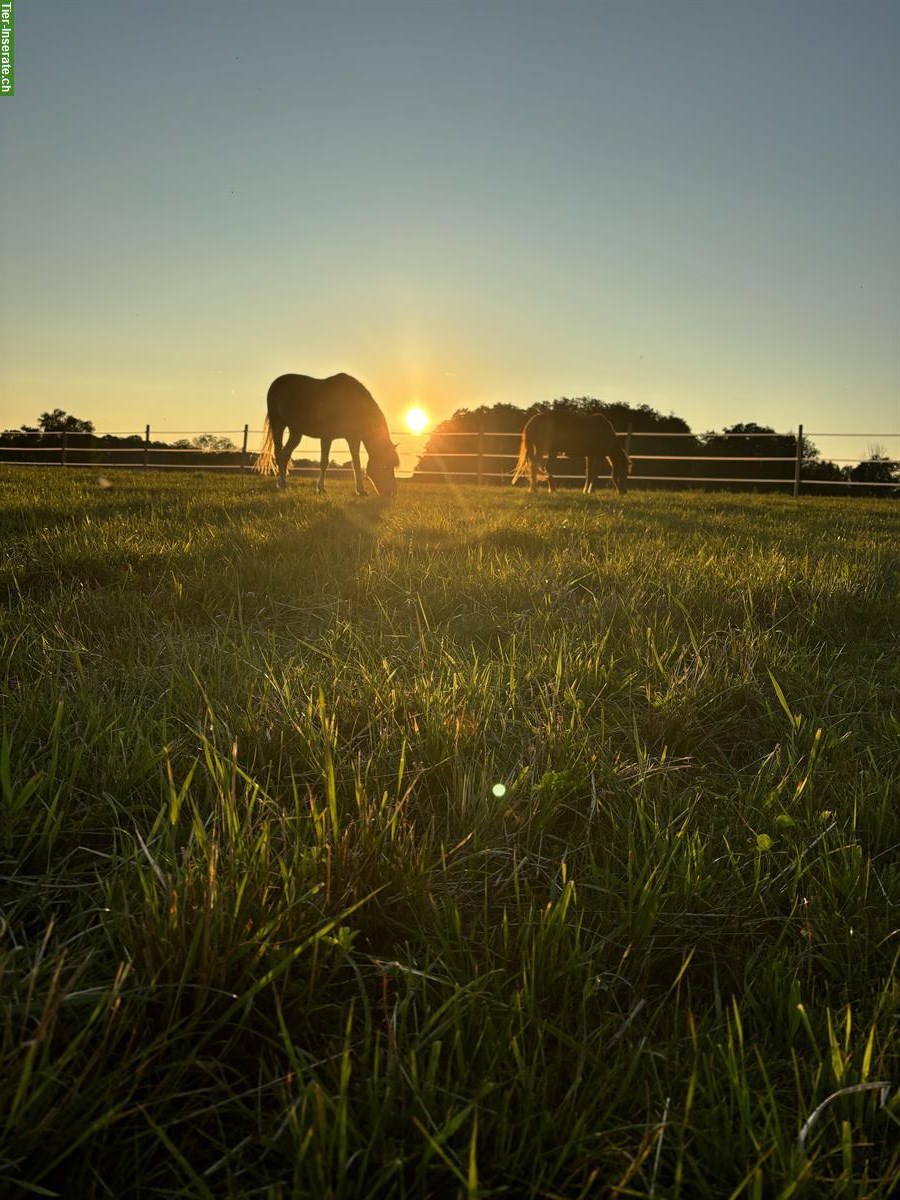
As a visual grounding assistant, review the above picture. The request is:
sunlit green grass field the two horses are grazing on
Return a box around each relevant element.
[0,469,900,1200]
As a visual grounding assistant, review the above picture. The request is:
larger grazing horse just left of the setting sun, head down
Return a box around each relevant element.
[257,374,400,496]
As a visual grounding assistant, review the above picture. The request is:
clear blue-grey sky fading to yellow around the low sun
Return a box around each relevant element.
[0,0,900,457]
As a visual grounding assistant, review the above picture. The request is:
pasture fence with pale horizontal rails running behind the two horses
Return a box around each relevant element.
[0,425,900,496]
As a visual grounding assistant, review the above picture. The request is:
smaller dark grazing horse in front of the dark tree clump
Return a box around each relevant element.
[512,408,631,496]
